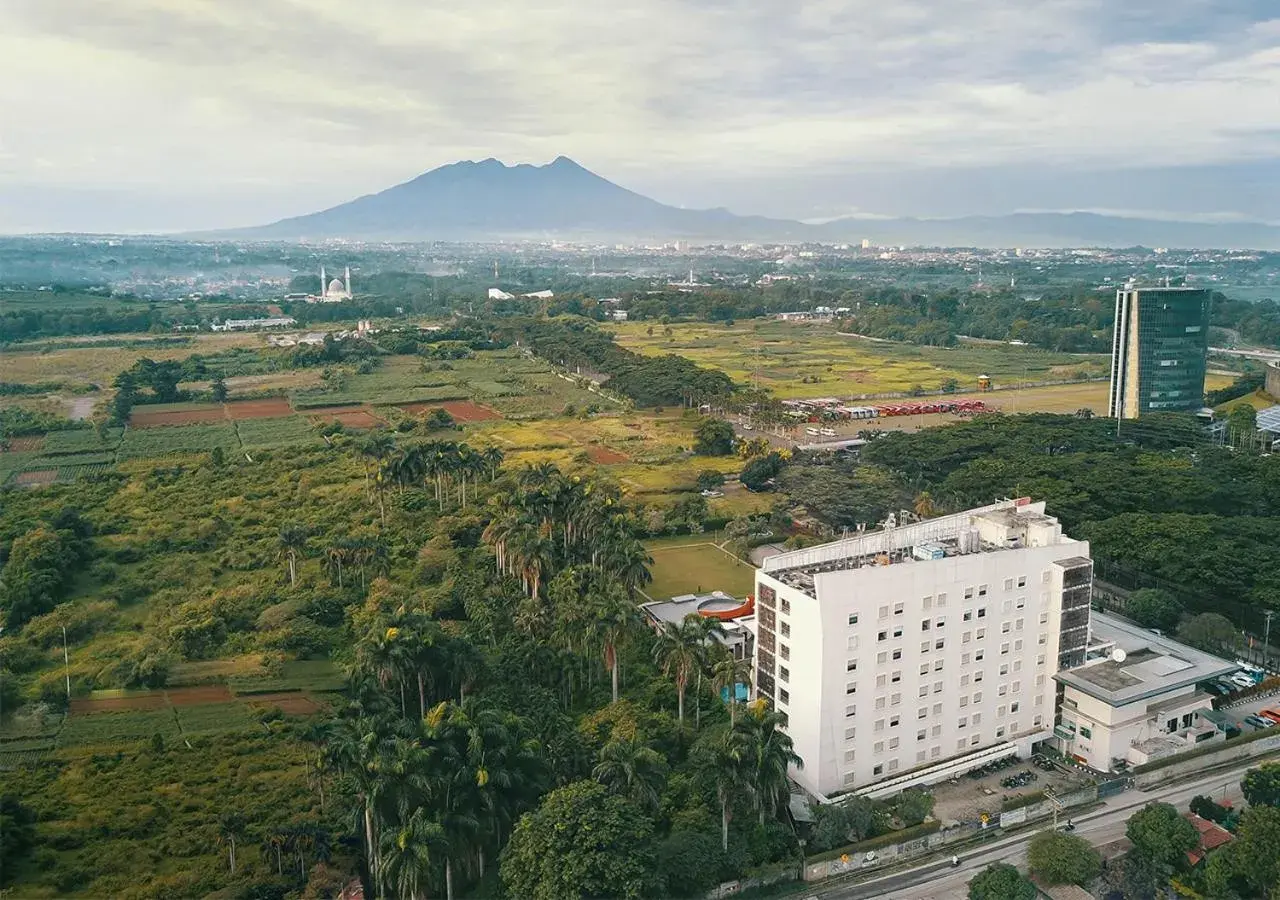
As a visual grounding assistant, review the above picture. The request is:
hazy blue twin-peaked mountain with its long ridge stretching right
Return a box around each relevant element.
[230,156,1280,250]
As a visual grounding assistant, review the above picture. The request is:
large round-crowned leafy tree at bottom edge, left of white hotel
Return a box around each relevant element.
[500,781,657,900]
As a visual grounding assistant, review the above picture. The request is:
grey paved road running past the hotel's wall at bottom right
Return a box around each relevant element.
[813,759,1260,900]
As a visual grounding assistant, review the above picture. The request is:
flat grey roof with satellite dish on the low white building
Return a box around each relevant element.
[1053,611,1239,707]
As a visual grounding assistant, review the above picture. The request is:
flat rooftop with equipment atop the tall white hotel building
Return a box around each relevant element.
[762,497,1076,597]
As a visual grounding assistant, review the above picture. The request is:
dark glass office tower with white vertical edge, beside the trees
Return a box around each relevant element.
[1108,287,1210,419]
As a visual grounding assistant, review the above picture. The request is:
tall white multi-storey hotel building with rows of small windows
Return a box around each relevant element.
[755,498,1093,796]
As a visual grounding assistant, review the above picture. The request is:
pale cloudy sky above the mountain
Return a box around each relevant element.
[0,0,1280,232]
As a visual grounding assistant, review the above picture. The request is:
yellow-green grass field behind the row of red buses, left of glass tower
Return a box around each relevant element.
[611,321,1107,397]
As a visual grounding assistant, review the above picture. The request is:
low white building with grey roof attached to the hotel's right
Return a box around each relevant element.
[1053,612,1238,772]
